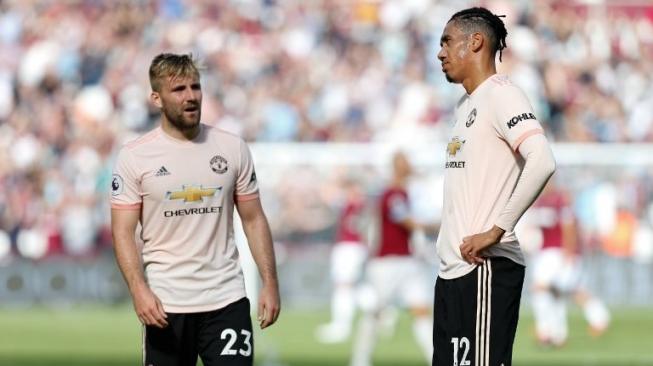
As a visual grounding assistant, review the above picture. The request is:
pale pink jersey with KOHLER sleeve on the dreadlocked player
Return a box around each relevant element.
[436,74,543,279]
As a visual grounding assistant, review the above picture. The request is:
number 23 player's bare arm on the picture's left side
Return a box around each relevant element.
[111,208,168,328]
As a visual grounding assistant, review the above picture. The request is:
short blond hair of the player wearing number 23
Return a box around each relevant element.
[150,53,199,92]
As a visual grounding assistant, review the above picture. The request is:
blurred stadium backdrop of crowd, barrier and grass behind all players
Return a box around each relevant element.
[0,0,653,366]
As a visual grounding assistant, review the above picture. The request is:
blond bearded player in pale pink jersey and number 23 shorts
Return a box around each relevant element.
[111,53,280,366]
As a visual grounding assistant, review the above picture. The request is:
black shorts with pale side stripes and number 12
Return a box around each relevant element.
[433,257,524,366]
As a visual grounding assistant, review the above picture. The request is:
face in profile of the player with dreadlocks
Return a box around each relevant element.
[438,22,471,83]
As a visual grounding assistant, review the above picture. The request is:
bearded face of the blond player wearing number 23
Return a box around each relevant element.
[158,75,202,131]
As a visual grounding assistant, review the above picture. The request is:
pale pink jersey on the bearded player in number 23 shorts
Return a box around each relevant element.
[111,124,258,313]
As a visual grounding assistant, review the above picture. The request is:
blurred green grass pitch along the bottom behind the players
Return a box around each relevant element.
[0,306,653,366]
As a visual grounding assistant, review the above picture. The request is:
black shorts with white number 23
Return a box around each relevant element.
[143,297,254,366]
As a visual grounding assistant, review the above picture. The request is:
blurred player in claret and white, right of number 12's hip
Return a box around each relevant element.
[530,179,610,347]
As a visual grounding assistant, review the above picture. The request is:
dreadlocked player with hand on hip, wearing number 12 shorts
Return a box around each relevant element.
[433,8,555,366]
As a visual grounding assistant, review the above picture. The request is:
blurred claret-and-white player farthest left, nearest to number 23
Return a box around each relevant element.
[316,177,367,343]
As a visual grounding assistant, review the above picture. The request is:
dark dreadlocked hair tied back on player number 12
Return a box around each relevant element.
[449,7,508,61]
